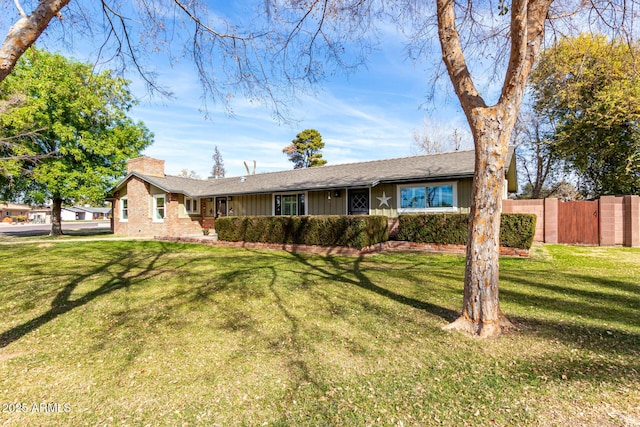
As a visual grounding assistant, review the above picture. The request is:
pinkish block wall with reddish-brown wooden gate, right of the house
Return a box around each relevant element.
[502,196,640,247]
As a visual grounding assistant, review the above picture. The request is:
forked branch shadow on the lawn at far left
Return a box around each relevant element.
[0,242,175,349]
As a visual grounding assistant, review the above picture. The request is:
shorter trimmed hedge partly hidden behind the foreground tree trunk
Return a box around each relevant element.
[397,213,536,249]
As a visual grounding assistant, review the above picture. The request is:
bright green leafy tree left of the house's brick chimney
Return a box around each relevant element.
[0,49,153,235]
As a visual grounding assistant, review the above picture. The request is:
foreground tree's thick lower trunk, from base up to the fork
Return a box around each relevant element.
[446,107,515,337]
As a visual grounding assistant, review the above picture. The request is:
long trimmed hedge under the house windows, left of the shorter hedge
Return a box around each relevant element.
[215,215,389,249]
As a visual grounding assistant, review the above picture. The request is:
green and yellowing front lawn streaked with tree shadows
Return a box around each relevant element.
[0,241,640,426]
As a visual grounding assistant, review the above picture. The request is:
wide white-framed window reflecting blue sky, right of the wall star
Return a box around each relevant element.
[400,183,457,212]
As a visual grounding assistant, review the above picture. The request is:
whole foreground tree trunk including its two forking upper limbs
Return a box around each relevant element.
[436,0,553,337]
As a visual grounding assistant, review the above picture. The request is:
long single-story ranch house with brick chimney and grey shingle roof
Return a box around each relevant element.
[111,149,517,236]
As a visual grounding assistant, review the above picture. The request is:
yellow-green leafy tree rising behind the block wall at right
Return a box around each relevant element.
[531,34,640,197]
